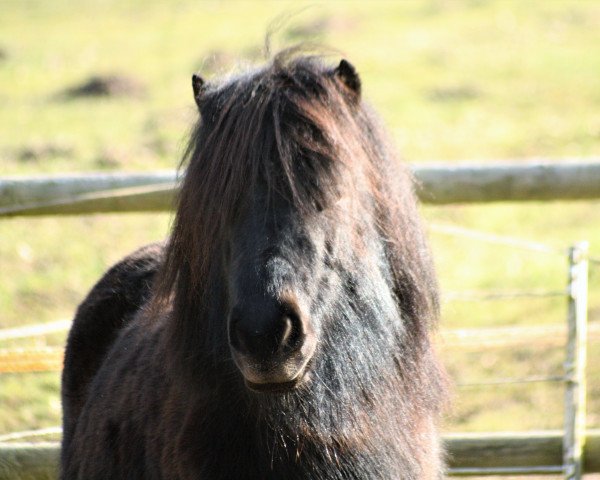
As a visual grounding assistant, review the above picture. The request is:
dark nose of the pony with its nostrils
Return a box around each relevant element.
[229,308,304,360]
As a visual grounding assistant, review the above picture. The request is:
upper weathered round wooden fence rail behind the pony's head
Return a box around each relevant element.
[0,158,600,216]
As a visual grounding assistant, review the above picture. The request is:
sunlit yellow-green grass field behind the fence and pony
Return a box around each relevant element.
[0,0,600,444]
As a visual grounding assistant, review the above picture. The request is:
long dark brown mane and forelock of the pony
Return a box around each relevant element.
[155,49,438,341]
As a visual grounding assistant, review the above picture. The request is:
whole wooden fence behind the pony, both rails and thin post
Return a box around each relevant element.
[0,158,600,480]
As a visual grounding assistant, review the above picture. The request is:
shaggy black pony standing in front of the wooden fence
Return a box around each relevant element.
[61,52,444,480]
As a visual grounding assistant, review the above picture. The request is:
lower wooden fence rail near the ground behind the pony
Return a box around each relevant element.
[0,430,600,480]
